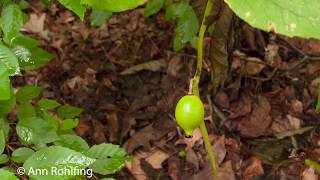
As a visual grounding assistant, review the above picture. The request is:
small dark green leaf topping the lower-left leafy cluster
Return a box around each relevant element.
[16,86,41,102]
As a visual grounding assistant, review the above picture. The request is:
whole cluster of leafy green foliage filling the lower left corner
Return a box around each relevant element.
[0,86,130,179]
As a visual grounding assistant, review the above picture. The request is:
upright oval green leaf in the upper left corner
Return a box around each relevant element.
[0,4,23,43]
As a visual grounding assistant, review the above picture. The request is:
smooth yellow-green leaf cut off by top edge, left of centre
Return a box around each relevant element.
[81,0,146,12]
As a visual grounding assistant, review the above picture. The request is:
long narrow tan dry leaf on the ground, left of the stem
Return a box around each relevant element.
[120,59,167,75]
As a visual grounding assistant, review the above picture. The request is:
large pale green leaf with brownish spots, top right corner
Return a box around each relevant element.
[225,0,320,38]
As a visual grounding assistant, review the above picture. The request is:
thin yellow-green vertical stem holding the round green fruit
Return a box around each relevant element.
[192,0,218,180]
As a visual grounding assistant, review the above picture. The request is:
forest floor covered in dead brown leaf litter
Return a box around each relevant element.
[14,3,320,180]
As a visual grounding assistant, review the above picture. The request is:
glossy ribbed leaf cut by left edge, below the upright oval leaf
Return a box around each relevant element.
[0,42,20,76]
